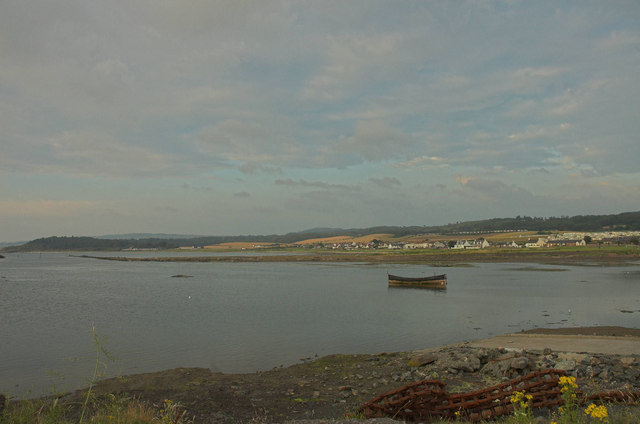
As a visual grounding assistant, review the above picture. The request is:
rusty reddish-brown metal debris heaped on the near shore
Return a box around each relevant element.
[359,370,640,423]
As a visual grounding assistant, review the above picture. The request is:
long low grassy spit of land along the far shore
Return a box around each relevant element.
[71,249,640,265]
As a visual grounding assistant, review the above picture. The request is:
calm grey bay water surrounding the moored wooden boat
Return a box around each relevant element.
[0,253,640,395]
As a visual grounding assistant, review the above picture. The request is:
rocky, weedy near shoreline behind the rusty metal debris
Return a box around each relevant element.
[48,327,640,424]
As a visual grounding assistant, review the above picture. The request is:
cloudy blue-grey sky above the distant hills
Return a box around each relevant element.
[0,0,640,241]
